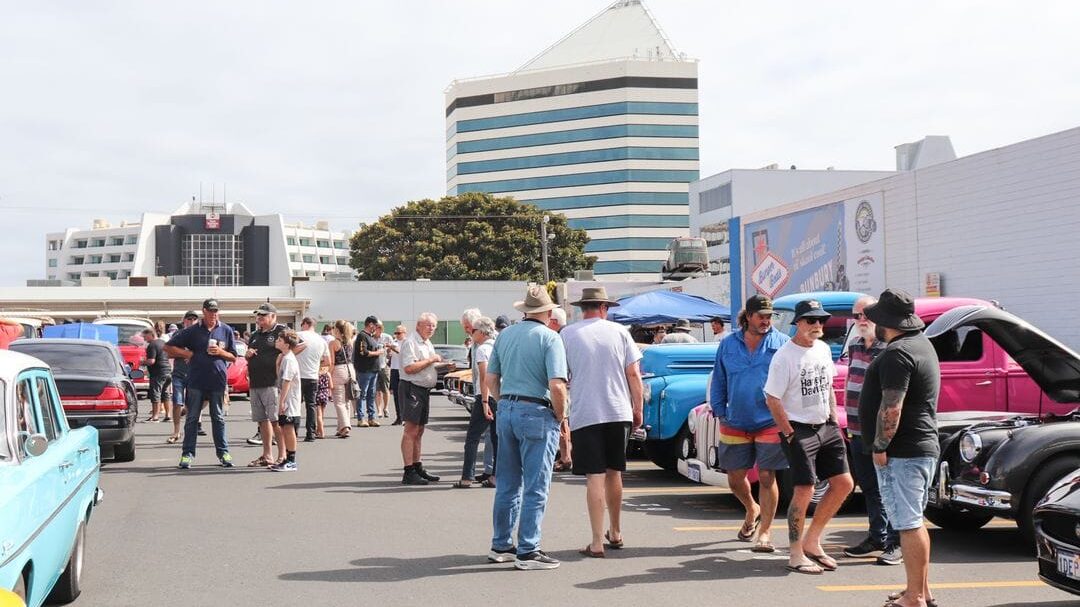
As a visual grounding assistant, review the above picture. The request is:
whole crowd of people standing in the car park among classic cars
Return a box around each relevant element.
[147,286,940,606]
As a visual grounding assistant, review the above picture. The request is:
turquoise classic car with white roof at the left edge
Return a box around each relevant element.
[0,350,103,607]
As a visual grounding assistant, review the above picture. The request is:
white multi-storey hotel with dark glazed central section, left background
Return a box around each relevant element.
[43,202,353,286]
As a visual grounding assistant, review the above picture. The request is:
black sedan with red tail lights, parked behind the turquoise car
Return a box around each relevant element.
[11,338,143,461]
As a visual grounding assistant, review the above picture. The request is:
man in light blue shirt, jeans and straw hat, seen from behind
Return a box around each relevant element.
[486,286,568,569]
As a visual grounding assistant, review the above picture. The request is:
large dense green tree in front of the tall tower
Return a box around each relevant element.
[349,192,596,282]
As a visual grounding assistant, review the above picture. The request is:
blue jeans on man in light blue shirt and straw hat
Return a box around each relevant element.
[491,400,558,554]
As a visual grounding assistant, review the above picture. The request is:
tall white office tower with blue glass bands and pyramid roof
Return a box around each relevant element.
[446,0,698,280]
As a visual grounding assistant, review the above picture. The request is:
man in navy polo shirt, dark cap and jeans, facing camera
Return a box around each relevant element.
[165,299,237,470]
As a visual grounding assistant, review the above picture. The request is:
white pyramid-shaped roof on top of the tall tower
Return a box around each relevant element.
[516,0,686,71]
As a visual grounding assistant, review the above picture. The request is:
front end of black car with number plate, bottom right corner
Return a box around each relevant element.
[1035,468,1080,594]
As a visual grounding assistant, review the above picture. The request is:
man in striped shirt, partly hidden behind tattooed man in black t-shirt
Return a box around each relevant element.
[843,296,904,565]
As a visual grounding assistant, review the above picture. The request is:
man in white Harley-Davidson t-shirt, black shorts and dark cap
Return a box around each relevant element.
[765,299,853,575]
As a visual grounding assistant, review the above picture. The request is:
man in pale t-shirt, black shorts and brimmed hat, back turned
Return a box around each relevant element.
[561,287,644,557]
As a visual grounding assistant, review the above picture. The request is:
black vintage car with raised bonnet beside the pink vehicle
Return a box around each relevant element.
[926,306,1080,542]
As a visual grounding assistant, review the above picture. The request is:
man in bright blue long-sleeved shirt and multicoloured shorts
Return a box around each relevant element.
[708,295,789,552]
